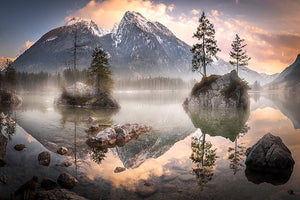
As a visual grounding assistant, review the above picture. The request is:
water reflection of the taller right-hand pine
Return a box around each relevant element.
[190,134,217,190]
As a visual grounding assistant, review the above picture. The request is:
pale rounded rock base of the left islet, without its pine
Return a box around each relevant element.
[55,82,120,108]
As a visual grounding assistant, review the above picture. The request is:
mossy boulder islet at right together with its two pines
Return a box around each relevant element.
[183,12,250,109]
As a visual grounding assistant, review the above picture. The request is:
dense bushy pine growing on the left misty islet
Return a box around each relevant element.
[88,47,114,93]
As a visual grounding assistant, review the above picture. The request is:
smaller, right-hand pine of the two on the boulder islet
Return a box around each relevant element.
[229,34,251,74]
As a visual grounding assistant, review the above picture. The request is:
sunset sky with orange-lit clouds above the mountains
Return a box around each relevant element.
[0,0,300,74]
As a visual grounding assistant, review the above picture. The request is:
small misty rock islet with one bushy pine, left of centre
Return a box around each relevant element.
[55,47,120,109]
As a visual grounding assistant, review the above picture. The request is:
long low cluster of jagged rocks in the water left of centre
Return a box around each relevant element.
[86,124,152,148]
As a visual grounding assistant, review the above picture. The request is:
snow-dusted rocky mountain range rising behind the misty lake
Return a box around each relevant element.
[13,11,278,85]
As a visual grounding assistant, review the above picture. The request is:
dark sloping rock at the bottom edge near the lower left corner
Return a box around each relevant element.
[12,176,38,200]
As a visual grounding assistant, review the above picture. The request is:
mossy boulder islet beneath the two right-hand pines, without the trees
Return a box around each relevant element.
[183,70,249,109]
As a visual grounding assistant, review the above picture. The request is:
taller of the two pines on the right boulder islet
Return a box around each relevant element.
[191,12,221,77]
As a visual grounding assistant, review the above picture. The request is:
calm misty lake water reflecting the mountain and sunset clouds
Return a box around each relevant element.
[0,91,300,199]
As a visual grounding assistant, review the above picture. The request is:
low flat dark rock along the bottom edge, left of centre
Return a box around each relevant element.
[35,189,86,200]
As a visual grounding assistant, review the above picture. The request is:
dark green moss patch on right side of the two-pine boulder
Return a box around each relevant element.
[221,78,250,100]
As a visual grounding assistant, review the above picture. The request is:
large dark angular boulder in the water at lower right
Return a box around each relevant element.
[245,133,295,171]
